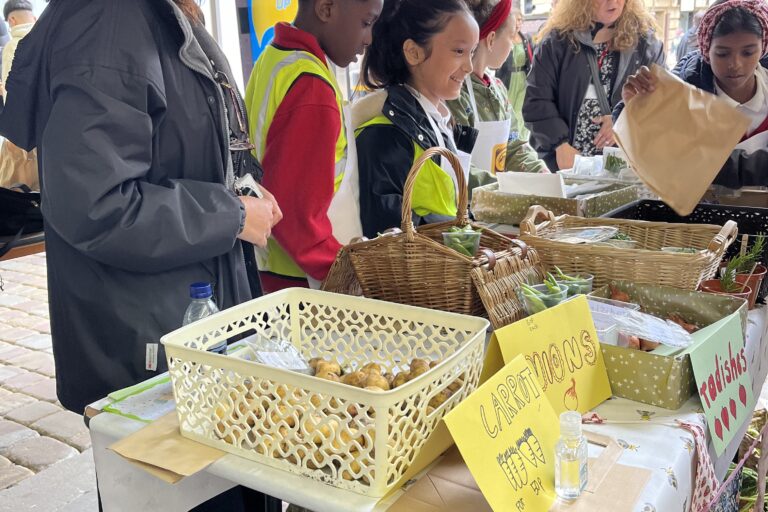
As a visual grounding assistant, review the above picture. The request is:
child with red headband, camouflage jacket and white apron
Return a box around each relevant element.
[448,0,549,174]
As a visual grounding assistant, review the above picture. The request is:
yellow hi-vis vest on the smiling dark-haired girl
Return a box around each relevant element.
[355,115,456,219]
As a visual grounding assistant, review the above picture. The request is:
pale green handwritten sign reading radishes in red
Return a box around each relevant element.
[690,313,755,455]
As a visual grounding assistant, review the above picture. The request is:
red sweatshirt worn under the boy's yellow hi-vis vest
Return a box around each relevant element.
[261,23,342,280]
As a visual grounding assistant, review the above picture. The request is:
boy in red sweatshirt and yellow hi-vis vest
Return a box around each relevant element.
[245,0,383,293]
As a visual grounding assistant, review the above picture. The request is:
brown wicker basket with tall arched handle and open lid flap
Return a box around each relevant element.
[340,148,542,327]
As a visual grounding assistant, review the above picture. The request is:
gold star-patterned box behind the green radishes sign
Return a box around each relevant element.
[592,281,747,410]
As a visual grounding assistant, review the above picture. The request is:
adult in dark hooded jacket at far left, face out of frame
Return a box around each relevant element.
[0,0,280,412]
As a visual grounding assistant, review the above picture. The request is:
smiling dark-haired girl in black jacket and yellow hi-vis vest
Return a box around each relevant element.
[352,0,479,238]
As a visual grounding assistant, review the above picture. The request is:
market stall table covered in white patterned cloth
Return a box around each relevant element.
[87,306,768,512]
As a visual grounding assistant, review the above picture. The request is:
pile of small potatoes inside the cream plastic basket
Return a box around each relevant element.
[208,358,463,484]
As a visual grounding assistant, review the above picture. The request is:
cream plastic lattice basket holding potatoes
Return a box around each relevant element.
[161,289,489,497]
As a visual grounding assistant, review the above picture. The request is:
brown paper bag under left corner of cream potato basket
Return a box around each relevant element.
[109,412,225,484]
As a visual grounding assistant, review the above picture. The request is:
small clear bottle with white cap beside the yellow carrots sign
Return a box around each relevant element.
[555,411,587,500]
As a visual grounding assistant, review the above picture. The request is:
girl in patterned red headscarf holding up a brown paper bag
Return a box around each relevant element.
[622,0,768,188]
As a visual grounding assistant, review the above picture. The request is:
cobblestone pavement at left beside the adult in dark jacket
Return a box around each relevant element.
[0,254,98,512]
